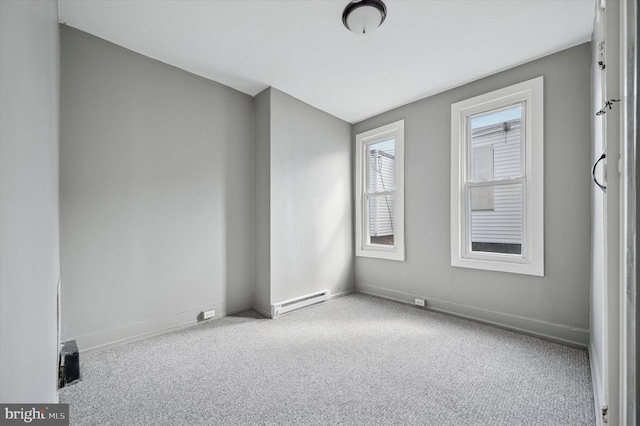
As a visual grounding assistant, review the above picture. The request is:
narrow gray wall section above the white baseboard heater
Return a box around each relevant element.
[270,89,353,302]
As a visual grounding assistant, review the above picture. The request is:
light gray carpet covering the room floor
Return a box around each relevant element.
[60,294,595,426]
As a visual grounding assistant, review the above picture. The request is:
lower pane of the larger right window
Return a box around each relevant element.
[469,183,524,254]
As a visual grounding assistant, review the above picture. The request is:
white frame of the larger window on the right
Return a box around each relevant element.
[451,77,544,276]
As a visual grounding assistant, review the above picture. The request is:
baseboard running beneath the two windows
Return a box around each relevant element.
[356,284,589,349]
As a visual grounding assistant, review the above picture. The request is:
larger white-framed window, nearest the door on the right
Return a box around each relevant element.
[451,77,544,276]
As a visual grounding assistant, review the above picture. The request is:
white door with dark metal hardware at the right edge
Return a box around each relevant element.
[590,0,622,425]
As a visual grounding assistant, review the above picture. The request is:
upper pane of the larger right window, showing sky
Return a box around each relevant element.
[469,104,524,182]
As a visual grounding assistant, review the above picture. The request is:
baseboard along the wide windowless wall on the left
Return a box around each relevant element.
[64,298,253,355]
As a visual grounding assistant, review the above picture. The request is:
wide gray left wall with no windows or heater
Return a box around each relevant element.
[60,26,253,350]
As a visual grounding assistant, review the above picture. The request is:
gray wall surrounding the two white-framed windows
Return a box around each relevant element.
[354,43,591,345]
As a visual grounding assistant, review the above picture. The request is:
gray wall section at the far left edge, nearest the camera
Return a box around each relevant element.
[0,1,60,403]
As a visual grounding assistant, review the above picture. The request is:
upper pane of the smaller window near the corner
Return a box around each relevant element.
[367,139,396,192]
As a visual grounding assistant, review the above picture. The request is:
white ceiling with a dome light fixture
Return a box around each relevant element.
[59,0,596,123]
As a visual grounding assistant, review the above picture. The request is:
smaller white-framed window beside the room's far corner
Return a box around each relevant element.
[355,120,404,260]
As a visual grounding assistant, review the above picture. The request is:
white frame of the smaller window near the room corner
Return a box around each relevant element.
[355,120,405,261]
